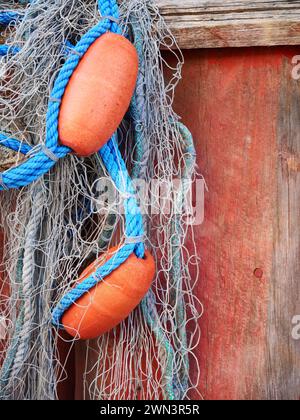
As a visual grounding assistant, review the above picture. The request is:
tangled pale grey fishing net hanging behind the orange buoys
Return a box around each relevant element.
[0,0,202,400]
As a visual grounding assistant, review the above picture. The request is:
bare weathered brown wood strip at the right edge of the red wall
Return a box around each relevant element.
[266,55,300,400]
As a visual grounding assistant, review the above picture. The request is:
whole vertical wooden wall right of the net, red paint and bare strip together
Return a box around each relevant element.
[165,48,300,400]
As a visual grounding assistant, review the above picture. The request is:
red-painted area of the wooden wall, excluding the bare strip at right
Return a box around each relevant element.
[166,48,299,399]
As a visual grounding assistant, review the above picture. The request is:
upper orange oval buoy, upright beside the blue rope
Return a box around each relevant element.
[58,32,138,156]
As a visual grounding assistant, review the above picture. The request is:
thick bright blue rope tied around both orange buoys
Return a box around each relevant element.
[0,0,145,327]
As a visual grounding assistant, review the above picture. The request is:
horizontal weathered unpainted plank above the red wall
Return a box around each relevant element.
[155,0,300,49]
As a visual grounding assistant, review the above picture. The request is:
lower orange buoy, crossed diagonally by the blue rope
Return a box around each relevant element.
[62,248,155,340]
